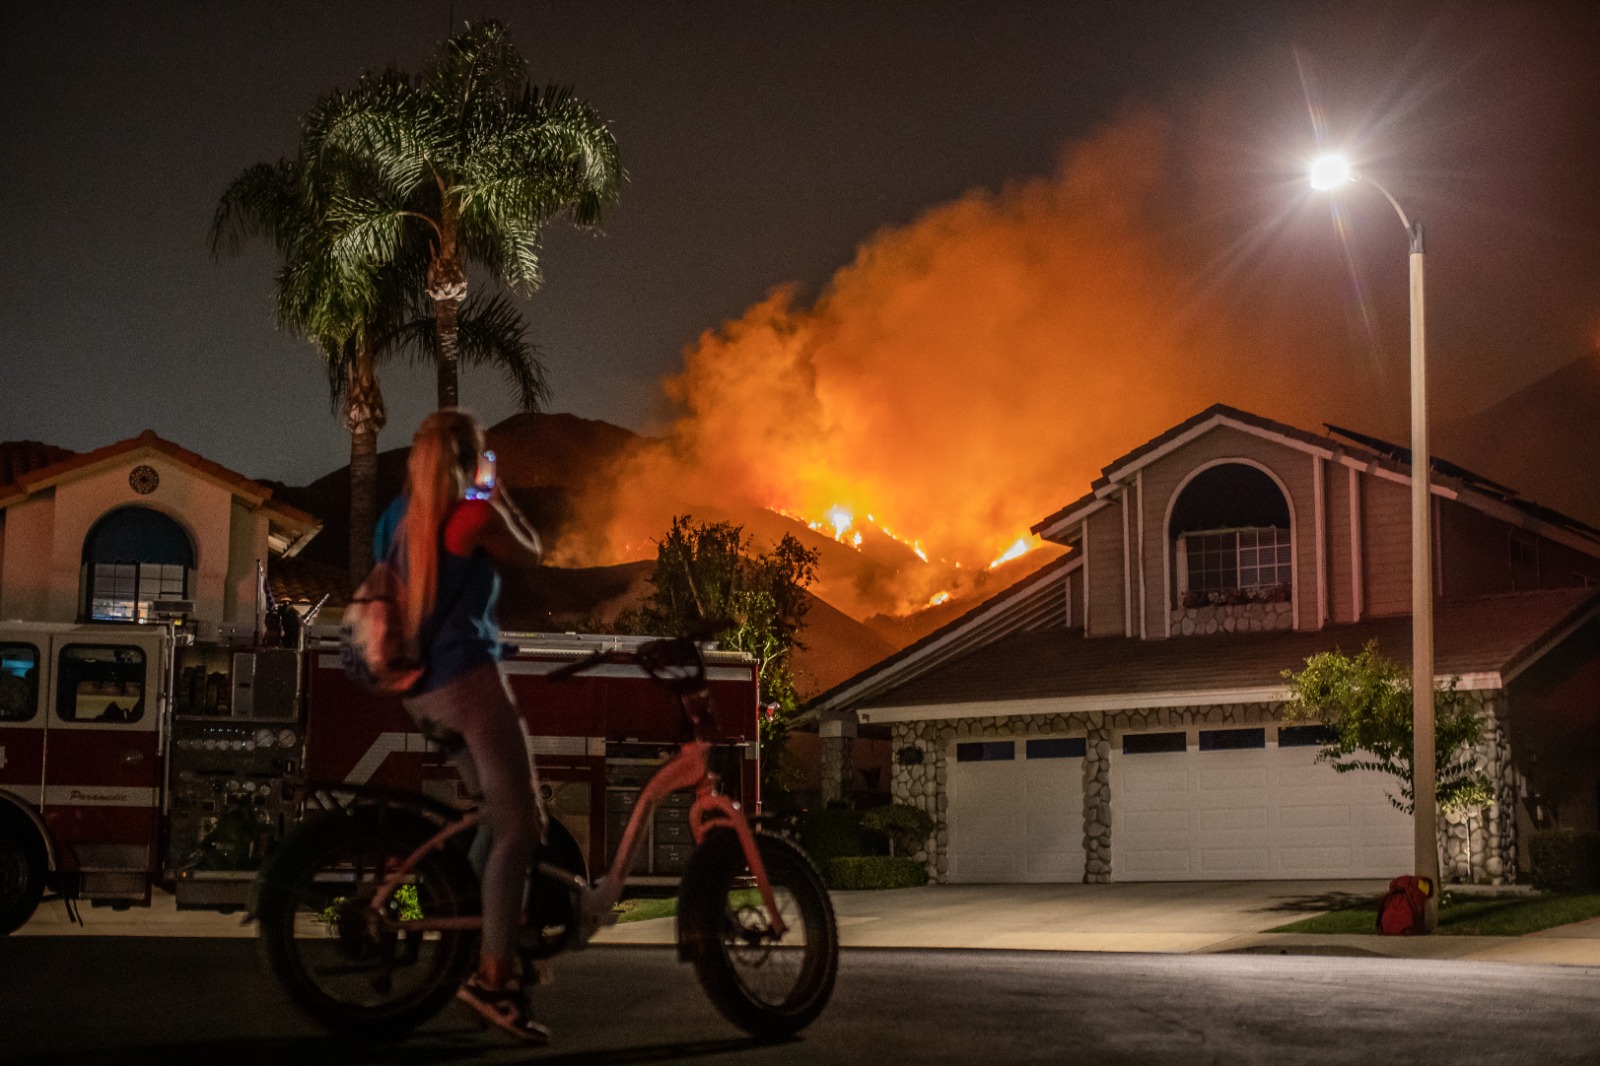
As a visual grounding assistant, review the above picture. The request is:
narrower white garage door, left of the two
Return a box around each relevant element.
[946,736,1083,884]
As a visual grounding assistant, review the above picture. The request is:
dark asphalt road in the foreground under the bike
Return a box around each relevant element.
[0,936,1600,1066]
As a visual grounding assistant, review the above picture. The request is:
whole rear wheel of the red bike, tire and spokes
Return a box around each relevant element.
[256,810,478,1037]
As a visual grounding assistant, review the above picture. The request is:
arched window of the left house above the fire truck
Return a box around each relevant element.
[83,507,195,621]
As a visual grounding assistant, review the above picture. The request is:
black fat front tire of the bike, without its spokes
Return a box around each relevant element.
[678,829,838,1039]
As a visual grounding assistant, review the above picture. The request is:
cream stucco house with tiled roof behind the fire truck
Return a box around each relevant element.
[0,431,322,640]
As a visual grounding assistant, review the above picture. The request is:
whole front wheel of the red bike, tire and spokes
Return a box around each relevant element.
[678,829,838,1039]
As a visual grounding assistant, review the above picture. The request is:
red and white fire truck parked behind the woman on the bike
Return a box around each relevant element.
[0,623,760,933]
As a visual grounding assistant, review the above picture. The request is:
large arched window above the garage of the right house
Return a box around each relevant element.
[1168,463,1294,607]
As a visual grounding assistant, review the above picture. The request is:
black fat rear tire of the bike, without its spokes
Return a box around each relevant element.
[256,808,478,1039]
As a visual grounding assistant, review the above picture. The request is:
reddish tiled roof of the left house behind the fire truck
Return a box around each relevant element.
[0,429,322,555]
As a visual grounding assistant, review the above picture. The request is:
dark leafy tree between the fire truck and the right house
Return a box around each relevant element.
[619,515,819,786]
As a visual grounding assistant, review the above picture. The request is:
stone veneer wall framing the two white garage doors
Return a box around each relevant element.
[891,693,1517,884]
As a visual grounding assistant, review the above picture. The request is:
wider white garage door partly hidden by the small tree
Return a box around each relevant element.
[1110,725,1413,880]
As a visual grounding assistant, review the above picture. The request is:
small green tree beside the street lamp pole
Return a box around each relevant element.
[1283,642,1493,815]
